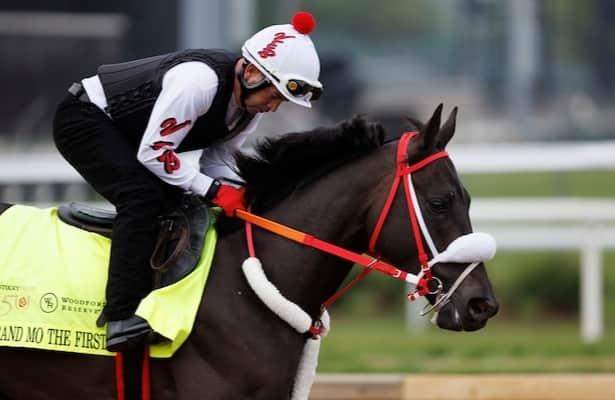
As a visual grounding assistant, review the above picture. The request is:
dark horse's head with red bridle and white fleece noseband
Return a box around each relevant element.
[369,105,498,331]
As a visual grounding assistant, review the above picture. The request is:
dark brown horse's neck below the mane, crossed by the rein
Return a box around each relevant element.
[248,148,392,312]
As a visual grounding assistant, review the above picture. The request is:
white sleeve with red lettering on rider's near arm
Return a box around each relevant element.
[137,61,218,195]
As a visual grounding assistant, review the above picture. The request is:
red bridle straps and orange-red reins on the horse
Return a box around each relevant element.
[236,132,448,307]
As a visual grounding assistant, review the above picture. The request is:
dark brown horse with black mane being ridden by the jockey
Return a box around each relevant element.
[0,105,498,400]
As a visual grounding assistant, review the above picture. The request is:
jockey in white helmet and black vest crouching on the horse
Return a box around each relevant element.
[53,12,322,352]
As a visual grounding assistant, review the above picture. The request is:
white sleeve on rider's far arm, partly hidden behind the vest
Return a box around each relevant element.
[199,113,263,181]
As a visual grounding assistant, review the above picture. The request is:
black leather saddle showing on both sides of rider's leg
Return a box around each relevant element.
[58,195,209,289]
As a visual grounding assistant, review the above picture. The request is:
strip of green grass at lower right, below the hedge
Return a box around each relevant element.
[318,315,615,373]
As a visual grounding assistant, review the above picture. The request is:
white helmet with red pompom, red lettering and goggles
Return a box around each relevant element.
[241,11,322,108]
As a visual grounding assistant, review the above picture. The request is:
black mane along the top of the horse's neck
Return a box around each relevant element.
[235,117,384,211]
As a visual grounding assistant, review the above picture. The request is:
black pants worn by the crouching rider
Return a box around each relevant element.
[53,94,182,321]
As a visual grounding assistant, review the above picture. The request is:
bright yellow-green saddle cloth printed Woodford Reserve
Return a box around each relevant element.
[0,205,217,358]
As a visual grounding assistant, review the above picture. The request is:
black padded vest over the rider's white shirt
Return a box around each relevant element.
[98,49,239,152]
